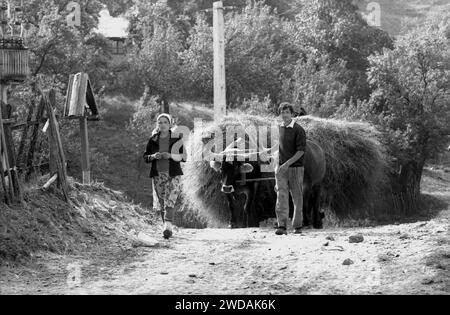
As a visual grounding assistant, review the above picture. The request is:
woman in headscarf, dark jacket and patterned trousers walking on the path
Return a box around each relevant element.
[143,114,186,239]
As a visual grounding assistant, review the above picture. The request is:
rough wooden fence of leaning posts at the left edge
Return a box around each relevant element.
[0,90,69,204]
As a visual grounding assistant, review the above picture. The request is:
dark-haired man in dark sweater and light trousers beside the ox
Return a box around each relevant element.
[275,103,306,235]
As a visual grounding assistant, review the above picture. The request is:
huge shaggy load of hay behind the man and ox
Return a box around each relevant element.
[183,113,390,226]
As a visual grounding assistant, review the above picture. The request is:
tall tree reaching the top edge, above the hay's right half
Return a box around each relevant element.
[293,0,392,99]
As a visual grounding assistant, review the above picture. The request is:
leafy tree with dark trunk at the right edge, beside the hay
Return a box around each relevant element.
[366,13,450,214]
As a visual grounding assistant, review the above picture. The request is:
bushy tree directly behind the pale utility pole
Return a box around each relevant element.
[181,2,302,105]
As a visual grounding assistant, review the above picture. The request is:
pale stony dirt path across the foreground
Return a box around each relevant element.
[2,210,450,294]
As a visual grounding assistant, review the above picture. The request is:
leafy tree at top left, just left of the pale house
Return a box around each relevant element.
[25,0,112,92]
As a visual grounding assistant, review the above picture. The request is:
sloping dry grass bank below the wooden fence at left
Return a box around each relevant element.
[0,175,156,265]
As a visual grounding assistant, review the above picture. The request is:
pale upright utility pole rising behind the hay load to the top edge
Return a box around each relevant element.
[213,1,227,121]
